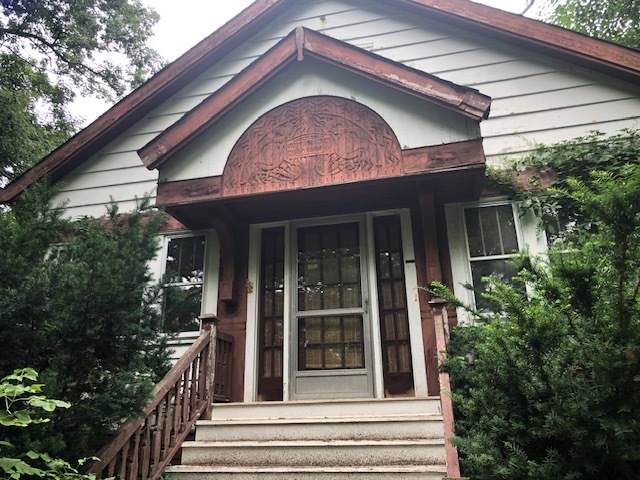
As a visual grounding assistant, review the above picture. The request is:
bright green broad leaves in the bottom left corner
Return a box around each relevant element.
[0,368,95,480]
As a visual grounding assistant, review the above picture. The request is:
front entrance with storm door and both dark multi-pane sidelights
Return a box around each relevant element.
[249,214,426,400]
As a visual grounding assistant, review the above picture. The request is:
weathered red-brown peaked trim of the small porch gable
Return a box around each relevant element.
[138,27,491,169]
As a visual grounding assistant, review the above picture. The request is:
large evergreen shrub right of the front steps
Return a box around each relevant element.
[435,132,640,480]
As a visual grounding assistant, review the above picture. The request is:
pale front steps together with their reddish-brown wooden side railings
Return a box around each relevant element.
[90,303,460,480]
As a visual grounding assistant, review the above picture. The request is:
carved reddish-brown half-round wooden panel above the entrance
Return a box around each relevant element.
[221,96,403,197]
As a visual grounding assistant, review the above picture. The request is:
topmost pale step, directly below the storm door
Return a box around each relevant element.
[212,397,440,420]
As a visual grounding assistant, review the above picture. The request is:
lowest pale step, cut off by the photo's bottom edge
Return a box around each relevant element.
[167,465,447,480]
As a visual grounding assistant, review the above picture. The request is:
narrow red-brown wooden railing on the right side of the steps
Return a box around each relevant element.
[429,298,461,479]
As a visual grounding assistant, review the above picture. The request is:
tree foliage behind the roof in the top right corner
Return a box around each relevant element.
[547,0,640,49]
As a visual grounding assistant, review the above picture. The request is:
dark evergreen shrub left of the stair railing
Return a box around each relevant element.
[0,185,167,459]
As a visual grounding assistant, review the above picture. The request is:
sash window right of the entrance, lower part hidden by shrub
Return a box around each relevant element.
[464,204,519,310]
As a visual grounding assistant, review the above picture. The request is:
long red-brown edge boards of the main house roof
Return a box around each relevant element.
[0,0,640,202]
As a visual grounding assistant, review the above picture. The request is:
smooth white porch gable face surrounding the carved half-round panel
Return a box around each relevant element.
[160,60,478,181]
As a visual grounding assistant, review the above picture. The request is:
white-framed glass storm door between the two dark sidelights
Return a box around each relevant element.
[291,222,373,399]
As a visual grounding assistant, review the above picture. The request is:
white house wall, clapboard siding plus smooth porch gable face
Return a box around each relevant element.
[50,0,640,336]
